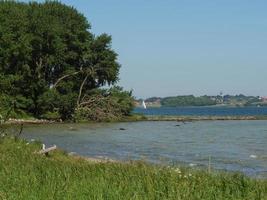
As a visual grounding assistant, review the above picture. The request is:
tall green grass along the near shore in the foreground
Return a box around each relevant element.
[0,138,267,200]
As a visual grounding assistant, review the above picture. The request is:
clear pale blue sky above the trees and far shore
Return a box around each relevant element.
[22,0,267,98]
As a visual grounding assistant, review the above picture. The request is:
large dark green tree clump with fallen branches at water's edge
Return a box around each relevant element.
[0,1,133,120]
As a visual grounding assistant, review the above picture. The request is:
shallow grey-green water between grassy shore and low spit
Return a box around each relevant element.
[24,121,267,178]
